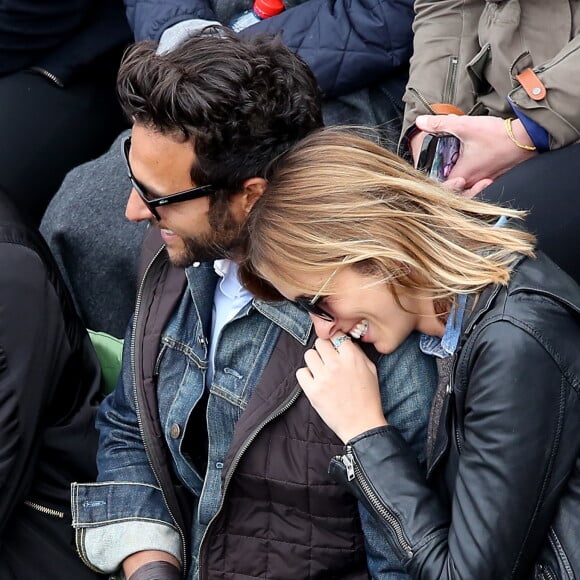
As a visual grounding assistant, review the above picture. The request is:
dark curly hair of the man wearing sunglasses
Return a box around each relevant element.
[117,26,323,193]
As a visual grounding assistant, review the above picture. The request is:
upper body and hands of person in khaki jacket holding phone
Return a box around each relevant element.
[401,0,580,194]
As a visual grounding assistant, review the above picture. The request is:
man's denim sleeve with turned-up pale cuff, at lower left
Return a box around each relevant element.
[72,324,181,573]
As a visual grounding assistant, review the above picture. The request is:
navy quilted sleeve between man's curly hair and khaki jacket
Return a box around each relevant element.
[241,0,414,97]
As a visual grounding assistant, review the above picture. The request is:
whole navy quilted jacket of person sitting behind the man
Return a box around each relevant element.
[125,0,414,98]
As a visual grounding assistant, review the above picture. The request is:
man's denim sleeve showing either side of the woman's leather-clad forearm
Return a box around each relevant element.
[359,334,437,580]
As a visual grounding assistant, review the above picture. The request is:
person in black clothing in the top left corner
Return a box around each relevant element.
[0,0,131,225]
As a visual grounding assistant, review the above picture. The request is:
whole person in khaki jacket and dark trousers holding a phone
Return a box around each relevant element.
[399,0,580,281]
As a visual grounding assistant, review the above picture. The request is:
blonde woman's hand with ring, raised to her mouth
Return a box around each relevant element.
[296,335,387,443]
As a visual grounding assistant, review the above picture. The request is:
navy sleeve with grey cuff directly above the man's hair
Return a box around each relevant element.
[125,0,216,40]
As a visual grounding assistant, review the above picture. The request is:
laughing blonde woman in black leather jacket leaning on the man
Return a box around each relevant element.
[242,129,580,580]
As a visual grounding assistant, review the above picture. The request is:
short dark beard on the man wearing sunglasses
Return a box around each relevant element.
[164,203,244,268]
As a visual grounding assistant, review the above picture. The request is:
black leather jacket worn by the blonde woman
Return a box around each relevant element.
[330,255,580,580]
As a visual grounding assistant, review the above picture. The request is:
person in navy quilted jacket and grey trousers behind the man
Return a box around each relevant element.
[41,0,414,337]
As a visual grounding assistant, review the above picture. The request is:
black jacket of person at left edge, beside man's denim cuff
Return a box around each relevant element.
[0,197,100,580]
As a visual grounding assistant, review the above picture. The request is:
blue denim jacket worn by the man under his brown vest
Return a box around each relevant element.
[72,242,435,578]
